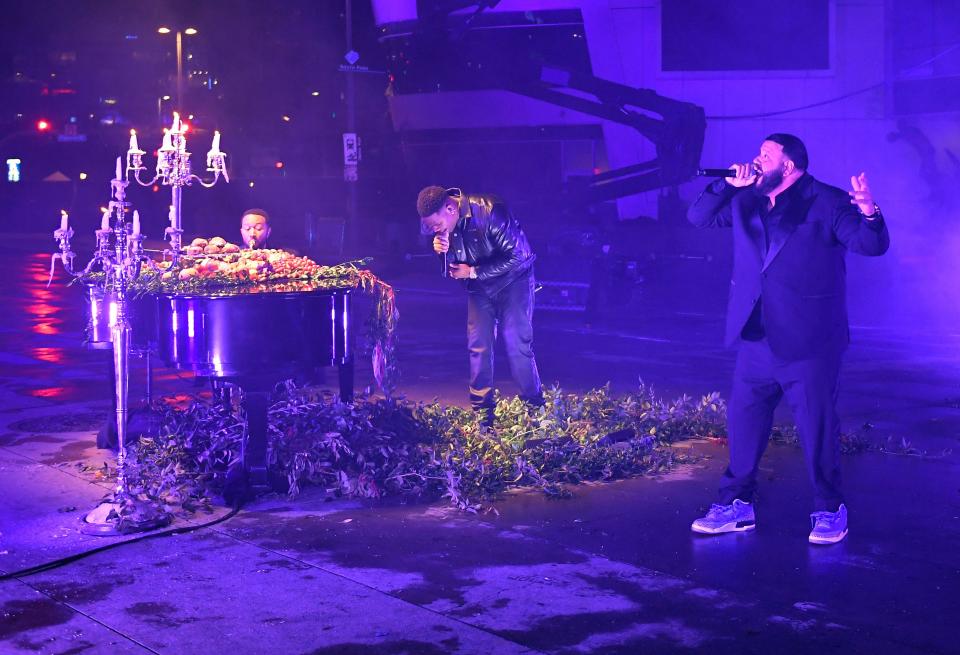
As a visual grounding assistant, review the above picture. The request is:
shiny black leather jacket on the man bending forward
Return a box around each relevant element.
[448,194,536,295]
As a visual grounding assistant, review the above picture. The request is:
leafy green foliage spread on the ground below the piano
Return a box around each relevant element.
[116,385,725,512]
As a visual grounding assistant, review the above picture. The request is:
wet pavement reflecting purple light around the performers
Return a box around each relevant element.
[0,237,960,655]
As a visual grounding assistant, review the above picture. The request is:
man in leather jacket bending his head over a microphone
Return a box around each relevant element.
[417,186,543,426]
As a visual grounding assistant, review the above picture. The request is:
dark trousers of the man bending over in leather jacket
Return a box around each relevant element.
[467,271,543,409]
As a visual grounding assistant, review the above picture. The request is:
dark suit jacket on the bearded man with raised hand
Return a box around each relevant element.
[687,174,890,361]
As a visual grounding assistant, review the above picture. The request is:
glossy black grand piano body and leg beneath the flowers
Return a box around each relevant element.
[87,285,354,504]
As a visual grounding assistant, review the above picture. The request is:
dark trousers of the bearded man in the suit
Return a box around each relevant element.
[720,339,843,512]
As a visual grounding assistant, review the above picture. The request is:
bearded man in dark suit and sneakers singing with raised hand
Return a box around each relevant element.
[687,134,890,544]
